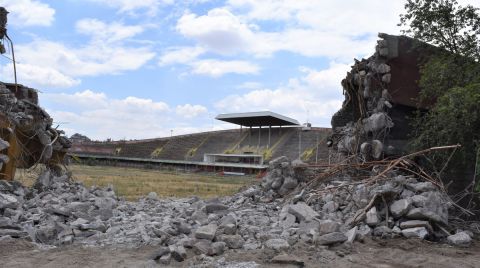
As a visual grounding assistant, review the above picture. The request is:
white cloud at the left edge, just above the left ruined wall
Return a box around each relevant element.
[0,63,80,88]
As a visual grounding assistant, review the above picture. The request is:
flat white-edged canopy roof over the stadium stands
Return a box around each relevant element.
[215,111,300,127]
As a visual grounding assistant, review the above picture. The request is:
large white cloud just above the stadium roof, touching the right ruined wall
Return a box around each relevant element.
[215,63,349,127]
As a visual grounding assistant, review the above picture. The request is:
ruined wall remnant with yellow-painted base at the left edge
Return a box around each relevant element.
[0,7,70,180]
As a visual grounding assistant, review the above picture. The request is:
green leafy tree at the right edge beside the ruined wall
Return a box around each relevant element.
[399,0,480,193]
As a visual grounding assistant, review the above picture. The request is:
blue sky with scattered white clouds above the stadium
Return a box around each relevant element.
[0,0,480,140]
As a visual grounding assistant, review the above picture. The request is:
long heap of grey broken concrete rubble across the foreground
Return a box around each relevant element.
[0,157,473,264]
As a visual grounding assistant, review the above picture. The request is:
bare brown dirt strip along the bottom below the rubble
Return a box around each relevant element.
[0,238,480,268]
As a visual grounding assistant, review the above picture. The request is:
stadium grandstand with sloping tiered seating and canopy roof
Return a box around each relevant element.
[69,111,331,173]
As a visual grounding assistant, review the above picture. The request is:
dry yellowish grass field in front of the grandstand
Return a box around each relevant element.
[16,165,257,200]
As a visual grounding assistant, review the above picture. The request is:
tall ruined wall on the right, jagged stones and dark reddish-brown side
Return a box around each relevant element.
[331,33,437,160]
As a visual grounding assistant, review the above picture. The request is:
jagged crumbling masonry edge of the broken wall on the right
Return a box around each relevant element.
[332,33,410,161]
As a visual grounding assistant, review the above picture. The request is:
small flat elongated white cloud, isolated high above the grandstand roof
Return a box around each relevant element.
[191,60,260,77]
